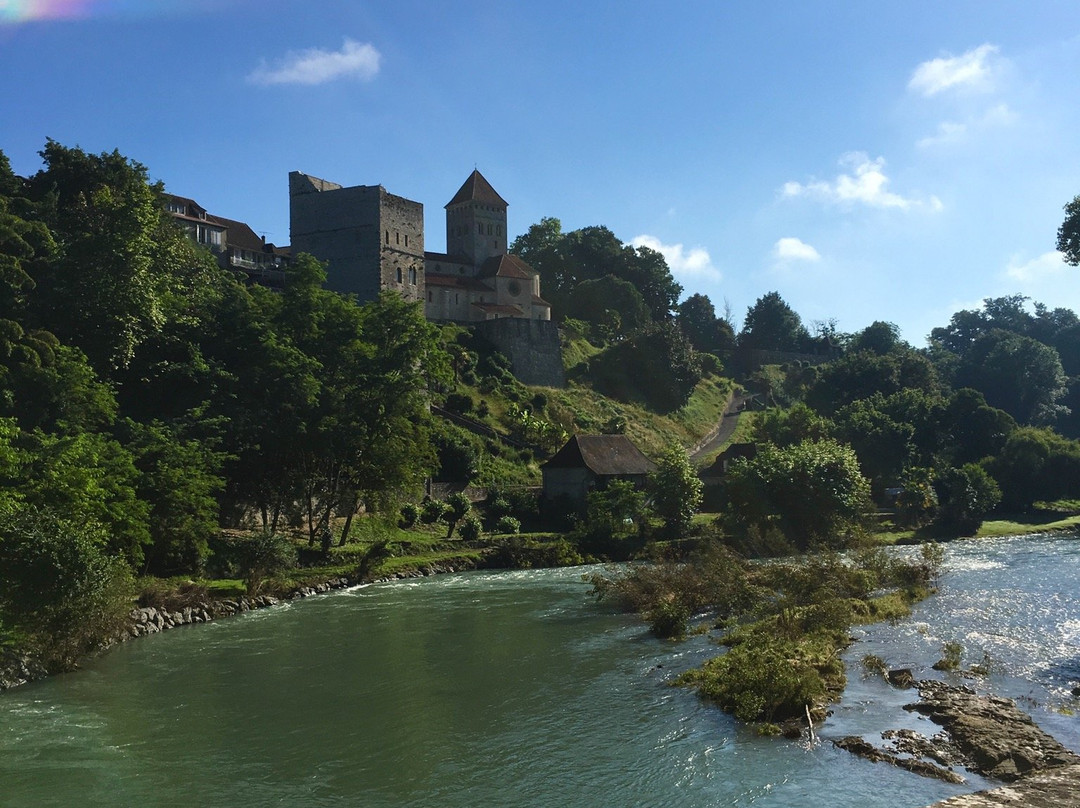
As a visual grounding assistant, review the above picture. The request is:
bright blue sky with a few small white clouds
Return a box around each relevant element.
[0,0,1080,347]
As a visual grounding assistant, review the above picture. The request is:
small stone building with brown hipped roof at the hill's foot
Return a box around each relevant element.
[541,435,657,504]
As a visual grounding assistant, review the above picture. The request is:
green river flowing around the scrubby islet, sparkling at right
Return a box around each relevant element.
[0,537,1080,808]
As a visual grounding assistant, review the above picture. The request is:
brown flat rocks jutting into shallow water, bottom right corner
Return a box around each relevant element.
[835,672,1080,790]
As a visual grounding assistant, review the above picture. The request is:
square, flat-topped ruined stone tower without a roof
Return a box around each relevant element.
[288,171,424,302]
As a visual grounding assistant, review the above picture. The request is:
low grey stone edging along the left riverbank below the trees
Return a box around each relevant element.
[0,557,476,692]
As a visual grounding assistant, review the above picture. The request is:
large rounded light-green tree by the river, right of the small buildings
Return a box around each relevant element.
[724,440,870,550]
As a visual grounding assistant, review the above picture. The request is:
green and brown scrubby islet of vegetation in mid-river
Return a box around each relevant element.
[591,542,942,732]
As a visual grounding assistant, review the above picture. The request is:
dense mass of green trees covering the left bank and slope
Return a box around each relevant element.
[0,140,449,656]
